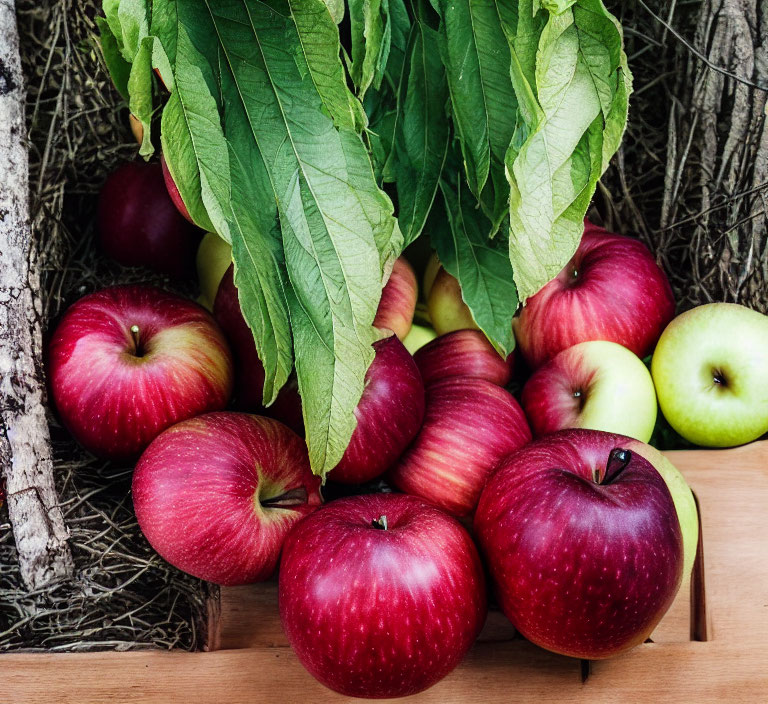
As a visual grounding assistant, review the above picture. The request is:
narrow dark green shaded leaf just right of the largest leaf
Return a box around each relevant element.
[394,21,450,246]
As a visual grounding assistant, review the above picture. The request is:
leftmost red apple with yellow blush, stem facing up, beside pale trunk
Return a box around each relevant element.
[48,286,233,460]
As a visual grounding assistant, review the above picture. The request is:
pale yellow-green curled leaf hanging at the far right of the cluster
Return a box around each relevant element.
[506,0,631,301]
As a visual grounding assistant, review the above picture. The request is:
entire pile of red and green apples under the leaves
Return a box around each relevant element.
[49,165,768,697]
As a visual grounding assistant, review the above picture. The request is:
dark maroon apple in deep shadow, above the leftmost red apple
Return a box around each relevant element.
[97,161,200,279]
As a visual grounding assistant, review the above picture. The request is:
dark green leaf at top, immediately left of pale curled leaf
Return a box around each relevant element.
[440,0,517,222]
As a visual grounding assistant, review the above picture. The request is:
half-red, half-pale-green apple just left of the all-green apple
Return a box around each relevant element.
[521,340,657,442]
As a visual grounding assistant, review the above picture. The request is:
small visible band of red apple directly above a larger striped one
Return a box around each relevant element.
[413,330,514,386]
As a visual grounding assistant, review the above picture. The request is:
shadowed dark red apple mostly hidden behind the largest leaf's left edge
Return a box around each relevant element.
[213,264,304,435]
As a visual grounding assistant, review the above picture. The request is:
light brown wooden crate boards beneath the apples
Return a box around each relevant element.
[0,442,768,704]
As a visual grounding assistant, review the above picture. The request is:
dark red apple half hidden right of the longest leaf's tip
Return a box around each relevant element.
[328,335,424,484]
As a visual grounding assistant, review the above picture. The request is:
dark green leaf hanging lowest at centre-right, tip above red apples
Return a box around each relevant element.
[430,180,518,357]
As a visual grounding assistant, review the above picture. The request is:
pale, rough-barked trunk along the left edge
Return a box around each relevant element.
[0,0,74,591]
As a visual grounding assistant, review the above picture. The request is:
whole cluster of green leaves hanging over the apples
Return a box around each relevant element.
[101,0,631,474]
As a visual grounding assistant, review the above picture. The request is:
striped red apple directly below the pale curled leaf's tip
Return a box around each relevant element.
[513,222,675,369]
